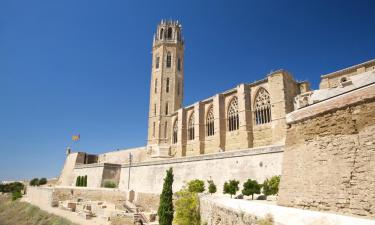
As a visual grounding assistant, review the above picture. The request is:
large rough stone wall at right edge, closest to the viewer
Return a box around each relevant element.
[278,85,375,218]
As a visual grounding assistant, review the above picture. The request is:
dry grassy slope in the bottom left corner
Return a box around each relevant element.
[0,195,75,225]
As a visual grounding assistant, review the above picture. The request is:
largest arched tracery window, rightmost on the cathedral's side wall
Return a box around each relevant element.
[254,88,271,125]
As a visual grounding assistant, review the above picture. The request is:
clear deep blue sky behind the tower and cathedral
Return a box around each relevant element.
[0,0,375,180]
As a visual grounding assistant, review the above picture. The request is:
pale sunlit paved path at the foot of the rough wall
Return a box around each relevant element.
[202,196,375,225]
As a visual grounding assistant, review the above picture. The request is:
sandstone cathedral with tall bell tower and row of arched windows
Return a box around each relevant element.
[147,21,309,158]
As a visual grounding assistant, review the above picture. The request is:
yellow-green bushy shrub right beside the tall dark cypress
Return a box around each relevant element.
[173,189,200,225]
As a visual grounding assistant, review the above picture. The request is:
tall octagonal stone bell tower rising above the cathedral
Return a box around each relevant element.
[147,20,184,157]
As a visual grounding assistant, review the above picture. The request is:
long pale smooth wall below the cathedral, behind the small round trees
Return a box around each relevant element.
[119,146,284,193]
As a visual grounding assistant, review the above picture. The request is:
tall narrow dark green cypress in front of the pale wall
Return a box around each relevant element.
[158,168,174,225]
